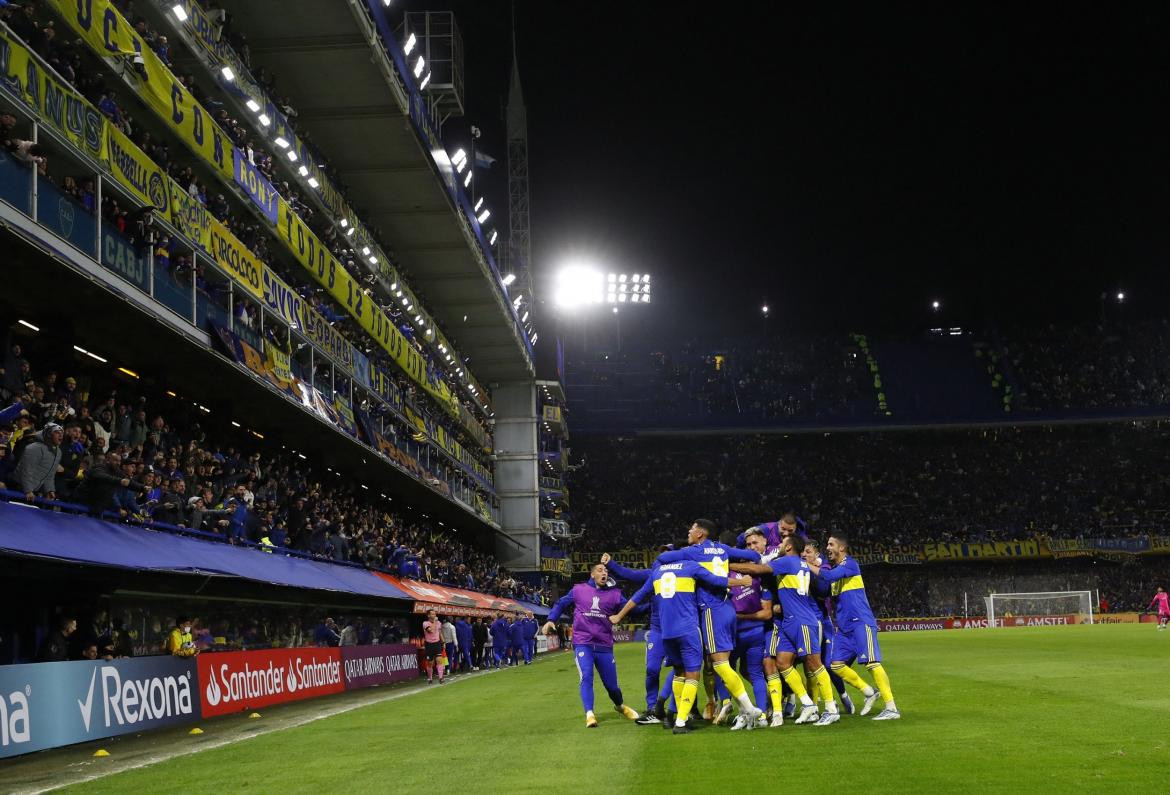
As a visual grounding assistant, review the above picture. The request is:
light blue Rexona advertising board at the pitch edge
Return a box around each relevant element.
[0,657,199,758]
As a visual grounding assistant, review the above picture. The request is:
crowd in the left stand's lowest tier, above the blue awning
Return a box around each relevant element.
[0,332,546,602]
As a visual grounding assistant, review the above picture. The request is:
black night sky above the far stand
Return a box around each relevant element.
[430,0,1170,336]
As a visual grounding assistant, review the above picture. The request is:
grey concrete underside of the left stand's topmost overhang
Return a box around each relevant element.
[223,0,535,383]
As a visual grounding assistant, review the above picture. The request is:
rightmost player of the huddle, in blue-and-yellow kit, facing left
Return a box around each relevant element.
[811,533,902,720]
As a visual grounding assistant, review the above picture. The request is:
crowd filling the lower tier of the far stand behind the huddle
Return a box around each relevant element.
[567,422,1170,549]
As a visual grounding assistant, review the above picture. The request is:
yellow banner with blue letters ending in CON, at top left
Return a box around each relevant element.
[47,0,233,179]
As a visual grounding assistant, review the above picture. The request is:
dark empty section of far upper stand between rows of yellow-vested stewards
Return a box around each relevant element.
[870,335,1003,422]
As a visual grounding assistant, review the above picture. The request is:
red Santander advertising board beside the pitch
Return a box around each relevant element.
[195,649,345,718]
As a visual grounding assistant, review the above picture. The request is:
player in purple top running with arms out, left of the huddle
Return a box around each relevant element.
[544,563,638,728]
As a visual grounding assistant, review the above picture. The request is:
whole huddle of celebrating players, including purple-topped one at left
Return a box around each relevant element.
[545,515,901,734]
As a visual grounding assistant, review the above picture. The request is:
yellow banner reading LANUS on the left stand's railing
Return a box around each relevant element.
[0,30,106,160]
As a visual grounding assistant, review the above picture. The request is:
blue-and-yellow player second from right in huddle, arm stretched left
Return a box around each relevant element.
[731,535,840,726]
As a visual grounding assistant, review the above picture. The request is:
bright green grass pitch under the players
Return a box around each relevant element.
[61,624,1170,794]
